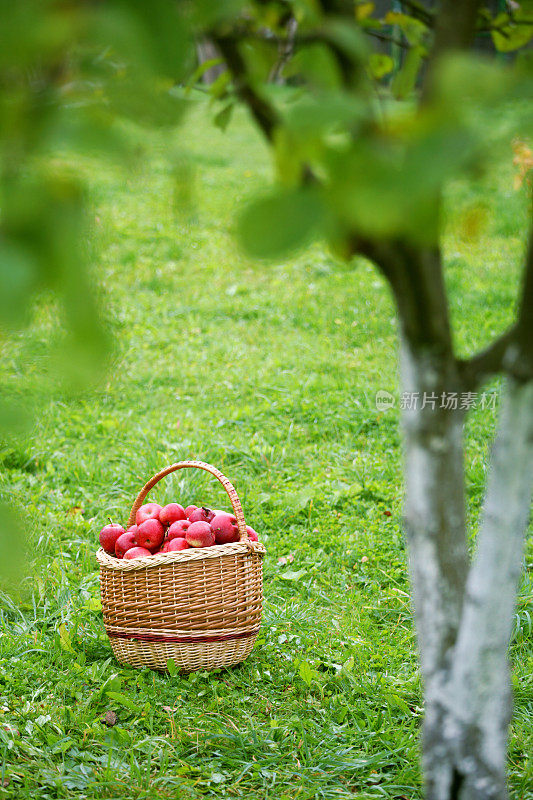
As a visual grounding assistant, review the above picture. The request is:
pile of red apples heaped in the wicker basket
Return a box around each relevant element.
[100,503,257,559]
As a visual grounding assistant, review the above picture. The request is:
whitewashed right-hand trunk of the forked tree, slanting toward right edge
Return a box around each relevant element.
[442,378,533,800]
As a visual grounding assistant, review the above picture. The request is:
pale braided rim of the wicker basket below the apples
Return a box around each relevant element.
[96,541,266,572]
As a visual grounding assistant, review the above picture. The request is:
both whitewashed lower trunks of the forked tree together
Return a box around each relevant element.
[401,341,533,800]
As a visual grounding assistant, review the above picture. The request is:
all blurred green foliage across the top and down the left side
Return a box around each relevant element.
[0,0,533,588]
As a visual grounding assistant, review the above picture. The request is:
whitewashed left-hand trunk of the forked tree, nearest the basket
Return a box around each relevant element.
[400,337,468,800]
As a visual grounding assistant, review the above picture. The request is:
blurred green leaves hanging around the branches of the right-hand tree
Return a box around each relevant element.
[224,3,533,259]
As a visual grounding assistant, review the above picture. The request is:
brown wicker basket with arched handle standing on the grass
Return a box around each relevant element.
[96,461,265,672]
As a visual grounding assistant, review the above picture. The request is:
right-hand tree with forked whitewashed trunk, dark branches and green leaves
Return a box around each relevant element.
[195,0,533,800]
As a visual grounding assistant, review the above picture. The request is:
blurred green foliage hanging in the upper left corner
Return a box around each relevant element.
[0,0,193,433]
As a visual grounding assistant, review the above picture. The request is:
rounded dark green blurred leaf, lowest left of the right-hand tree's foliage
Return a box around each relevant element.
[239,189,322,259]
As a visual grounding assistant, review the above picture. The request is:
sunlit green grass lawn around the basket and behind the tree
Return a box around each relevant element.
[0,101,533,800]
